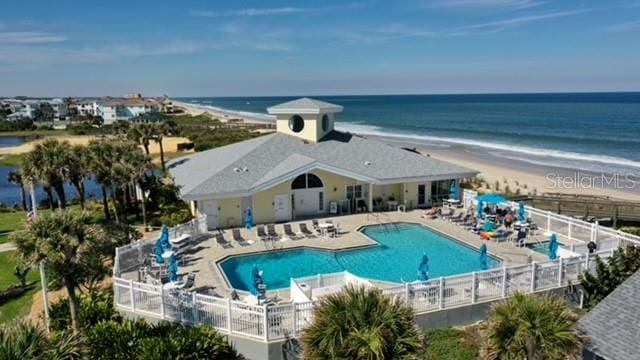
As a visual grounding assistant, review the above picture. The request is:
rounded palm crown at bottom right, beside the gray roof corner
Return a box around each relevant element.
[481,293,583,360]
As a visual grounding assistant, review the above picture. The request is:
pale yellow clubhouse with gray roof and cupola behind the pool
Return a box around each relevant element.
[169,98,477,229]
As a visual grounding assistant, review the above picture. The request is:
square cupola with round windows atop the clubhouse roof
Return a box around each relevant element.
[267,98,342,142]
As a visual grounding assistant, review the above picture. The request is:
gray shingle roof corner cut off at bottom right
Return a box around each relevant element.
[578,271,640,360]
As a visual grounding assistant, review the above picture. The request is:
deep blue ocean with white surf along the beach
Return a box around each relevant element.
[176,92,640,177]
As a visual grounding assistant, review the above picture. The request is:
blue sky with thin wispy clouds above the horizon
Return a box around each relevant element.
[0,0,640,97]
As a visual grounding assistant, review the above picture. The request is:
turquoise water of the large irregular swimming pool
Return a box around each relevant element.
[220,223,500,290]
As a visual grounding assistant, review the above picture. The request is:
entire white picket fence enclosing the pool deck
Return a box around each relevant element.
[113,201,640,341]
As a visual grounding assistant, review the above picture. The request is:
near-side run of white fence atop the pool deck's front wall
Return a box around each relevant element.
[113,250,613,341]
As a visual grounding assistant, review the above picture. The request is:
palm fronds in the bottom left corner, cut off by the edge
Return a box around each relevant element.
[0,321,85,360]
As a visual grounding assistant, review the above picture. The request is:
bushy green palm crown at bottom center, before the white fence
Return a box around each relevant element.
[302,286,424,359]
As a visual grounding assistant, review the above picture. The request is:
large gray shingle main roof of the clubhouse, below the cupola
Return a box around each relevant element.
[169,131,477,199]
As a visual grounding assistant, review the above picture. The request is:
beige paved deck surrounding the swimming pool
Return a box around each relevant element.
[123,210,580,301]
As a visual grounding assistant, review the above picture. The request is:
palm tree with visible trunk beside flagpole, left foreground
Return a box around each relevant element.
[12,210,109,334]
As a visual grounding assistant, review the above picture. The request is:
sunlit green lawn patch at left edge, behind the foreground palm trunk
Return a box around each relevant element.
[0,251,40,323]
